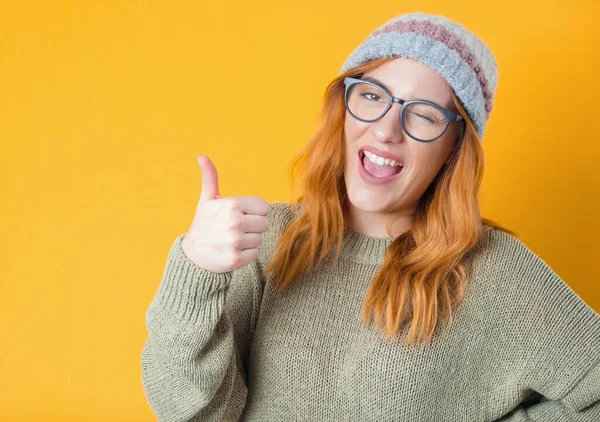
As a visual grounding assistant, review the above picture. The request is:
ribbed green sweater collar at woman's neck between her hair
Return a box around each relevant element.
[340,227,394,265]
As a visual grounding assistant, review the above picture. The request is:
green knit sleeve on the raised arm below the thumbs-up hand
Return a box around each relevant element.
[141,235,260,422]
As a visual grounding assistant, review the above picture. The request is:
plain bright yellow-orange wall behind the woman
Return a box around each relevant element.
[0,0,600,421]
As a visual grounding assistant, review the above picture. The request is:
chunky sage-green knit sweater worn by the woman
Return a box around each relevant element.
[141,202,600,422]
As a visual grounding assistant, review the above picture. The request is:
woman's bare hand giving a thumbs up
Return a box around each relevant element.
[181,155,269,273]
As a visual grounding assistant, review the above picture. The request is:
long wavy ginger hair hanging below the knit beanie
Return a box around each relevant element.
[266,57,518,344]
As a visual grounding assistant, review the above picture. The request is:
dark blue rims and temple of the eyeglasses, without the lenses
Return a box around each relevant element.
[344,77,466,142]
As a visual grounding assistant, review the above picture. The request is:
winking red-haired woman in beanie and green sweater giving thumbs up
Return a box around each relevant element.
[142,14,600,422]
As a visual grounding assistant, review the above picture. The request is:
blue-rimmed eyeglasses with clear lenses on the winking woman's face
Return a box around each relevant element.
[344,78,464,142]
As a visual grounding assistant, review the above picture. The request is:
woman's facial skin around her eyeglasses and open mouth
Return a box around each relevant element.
[344,58,461,218]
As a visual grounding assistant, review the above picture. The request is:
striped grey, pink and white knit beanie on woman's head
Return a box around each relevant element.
[340,13,498,140]
